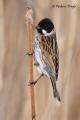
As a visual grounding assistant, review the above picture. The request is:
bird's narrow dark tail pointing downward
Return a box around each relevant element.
[50,78,61,101]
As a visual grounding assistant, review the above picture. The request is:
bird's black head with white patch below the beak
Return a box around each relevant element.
[36,18,54,35]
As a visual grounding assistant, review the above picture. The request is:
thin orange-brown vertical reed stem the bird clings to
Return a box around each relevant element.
[26,9,36,120]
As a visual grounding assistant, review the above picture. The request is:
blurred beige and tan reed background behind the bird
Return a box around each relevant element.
[0,0,80,120]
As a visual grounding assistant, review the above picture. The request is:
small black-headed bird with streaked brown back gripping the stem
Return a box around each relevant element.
[28,18,61,101]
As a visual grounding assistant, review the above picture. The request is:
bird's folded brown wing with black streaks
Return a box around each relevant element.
[40,35,59,80]
